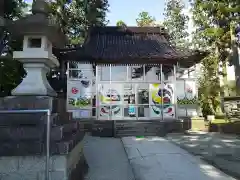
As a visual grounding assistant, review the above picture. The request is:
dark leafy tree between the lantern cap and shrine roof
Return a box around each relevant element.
[50,0,109,45]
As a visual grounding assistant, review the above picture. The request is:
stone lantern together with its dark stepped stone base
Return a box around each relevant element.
[0,0,87,180]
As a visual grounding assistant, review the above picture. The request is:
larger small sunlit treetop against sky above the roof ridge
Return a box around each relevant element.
[136,11,156,27]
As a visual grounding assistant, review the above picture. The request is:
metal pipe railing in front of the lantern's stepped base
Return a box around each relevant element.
[0,109,51,180]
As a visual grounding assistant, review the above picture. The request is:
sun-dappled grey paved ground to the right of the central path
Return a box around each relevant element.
[167,132,240,179]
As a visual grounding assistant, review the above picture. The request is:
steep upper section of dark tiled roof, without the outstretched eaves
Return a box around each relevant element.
[83,27,178,63]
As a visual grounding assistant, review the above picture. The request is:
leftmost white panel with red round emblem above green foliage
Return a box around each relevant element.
[67,80,92,110]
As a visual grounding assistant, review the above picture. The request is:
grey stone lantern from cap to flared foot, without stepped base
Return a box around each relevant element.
[8,0,65,96]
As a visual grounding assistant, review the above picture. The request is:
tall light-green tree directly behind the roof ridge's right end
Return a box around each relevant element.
[163,0,189,47]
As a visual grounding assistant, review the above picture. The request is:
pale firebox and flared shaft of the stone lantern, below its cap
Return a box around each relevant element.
[12,36,59,96]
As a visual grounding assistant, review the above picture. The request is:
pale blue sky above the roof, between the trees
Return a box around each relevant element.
[26,0,187,26]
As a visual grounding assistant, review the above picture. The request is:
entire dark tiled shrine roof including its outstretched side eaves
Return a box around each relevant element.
[56,27,208,64]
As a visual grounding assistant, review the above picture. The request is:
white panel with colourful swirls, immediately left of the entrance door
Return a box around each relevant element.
[98,84,123,119]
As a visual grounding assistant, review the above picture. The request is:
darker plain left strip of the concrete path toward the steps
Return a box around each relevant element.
[84,136,135,180]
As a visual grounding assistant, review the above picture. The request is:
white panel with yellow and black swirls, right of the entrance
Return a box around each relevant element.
[149,83,175,118]
